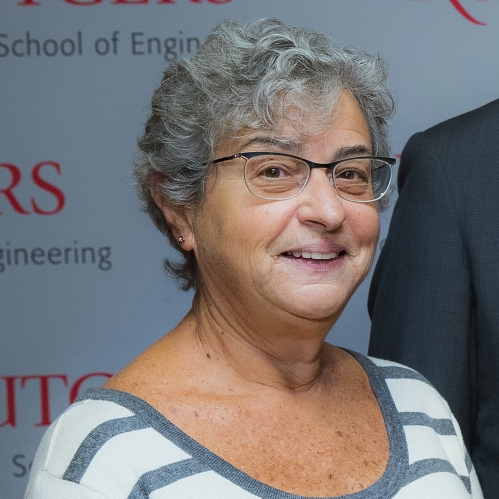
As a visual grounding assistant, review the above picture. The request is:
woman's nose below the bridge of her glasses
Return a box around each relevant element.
[298,169,349,230]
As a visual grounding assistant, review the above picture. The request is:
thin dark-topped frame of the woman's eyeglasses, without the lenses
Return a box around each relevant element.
[210,151,397,203]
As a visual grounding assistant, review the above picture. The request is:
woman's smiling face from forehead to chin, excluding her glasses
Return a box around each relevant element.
[189,92,379,319]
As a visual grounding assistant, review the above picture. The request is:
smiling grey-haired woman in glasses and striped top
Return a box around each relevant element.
[27,20,481,499]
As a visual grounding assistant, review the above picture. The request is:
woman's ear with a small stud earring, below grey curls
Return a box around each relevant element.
[150,175,196,251]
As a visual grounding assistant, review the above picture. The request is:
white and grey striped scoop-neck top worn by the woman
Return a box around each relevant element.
[25,353,483,499]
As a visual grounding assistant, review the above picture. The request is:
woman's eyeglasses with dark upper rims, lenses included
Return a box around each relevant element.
[212,152,396,203]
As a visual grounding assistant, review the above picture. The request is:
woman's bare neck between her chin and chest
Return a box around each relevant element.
[189,291,342,392]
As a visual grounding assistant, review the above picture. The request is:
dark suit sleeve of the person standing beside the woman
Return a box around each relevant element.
[368,133,473,448]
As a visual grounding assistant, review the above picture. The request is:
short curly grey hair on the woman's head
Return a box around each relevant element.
[134,19,394,290]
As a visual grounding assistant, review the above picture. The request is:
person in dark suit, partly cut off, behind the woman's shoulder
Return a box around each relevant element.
[369,100,499,499]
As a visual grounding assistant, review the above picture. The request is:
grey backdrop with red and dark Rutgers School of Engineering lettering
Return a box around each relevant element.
[0,0,499,499]
